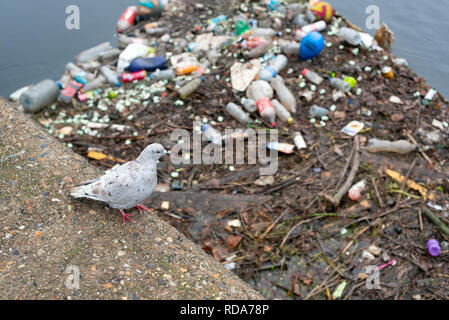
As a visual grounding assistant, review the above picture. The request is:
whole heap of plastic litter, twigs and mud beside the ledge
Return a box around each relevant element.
[12,0,449,299]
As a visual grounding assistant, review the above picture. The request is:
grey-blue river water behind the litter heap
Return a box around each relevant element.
[0,0,449,97]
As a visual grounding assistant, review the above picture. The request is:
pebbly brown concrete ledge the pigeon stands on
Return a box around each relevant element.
[0,98,263,299]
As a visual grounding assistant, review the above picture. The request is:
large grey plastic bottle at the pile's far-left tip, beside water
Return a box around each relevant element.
[20,79,59,112]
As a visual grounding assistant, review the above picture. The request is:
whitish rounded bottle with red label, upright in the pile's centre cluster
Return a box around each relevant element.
[247,80,276,128]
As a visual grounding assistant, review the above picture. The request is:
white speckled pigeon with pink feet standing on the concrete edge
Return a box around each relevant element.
[70,143,169,223]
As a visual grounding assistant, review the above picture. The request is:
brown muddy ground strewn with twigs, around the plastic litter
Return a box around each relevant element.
[28,1,449,299]
